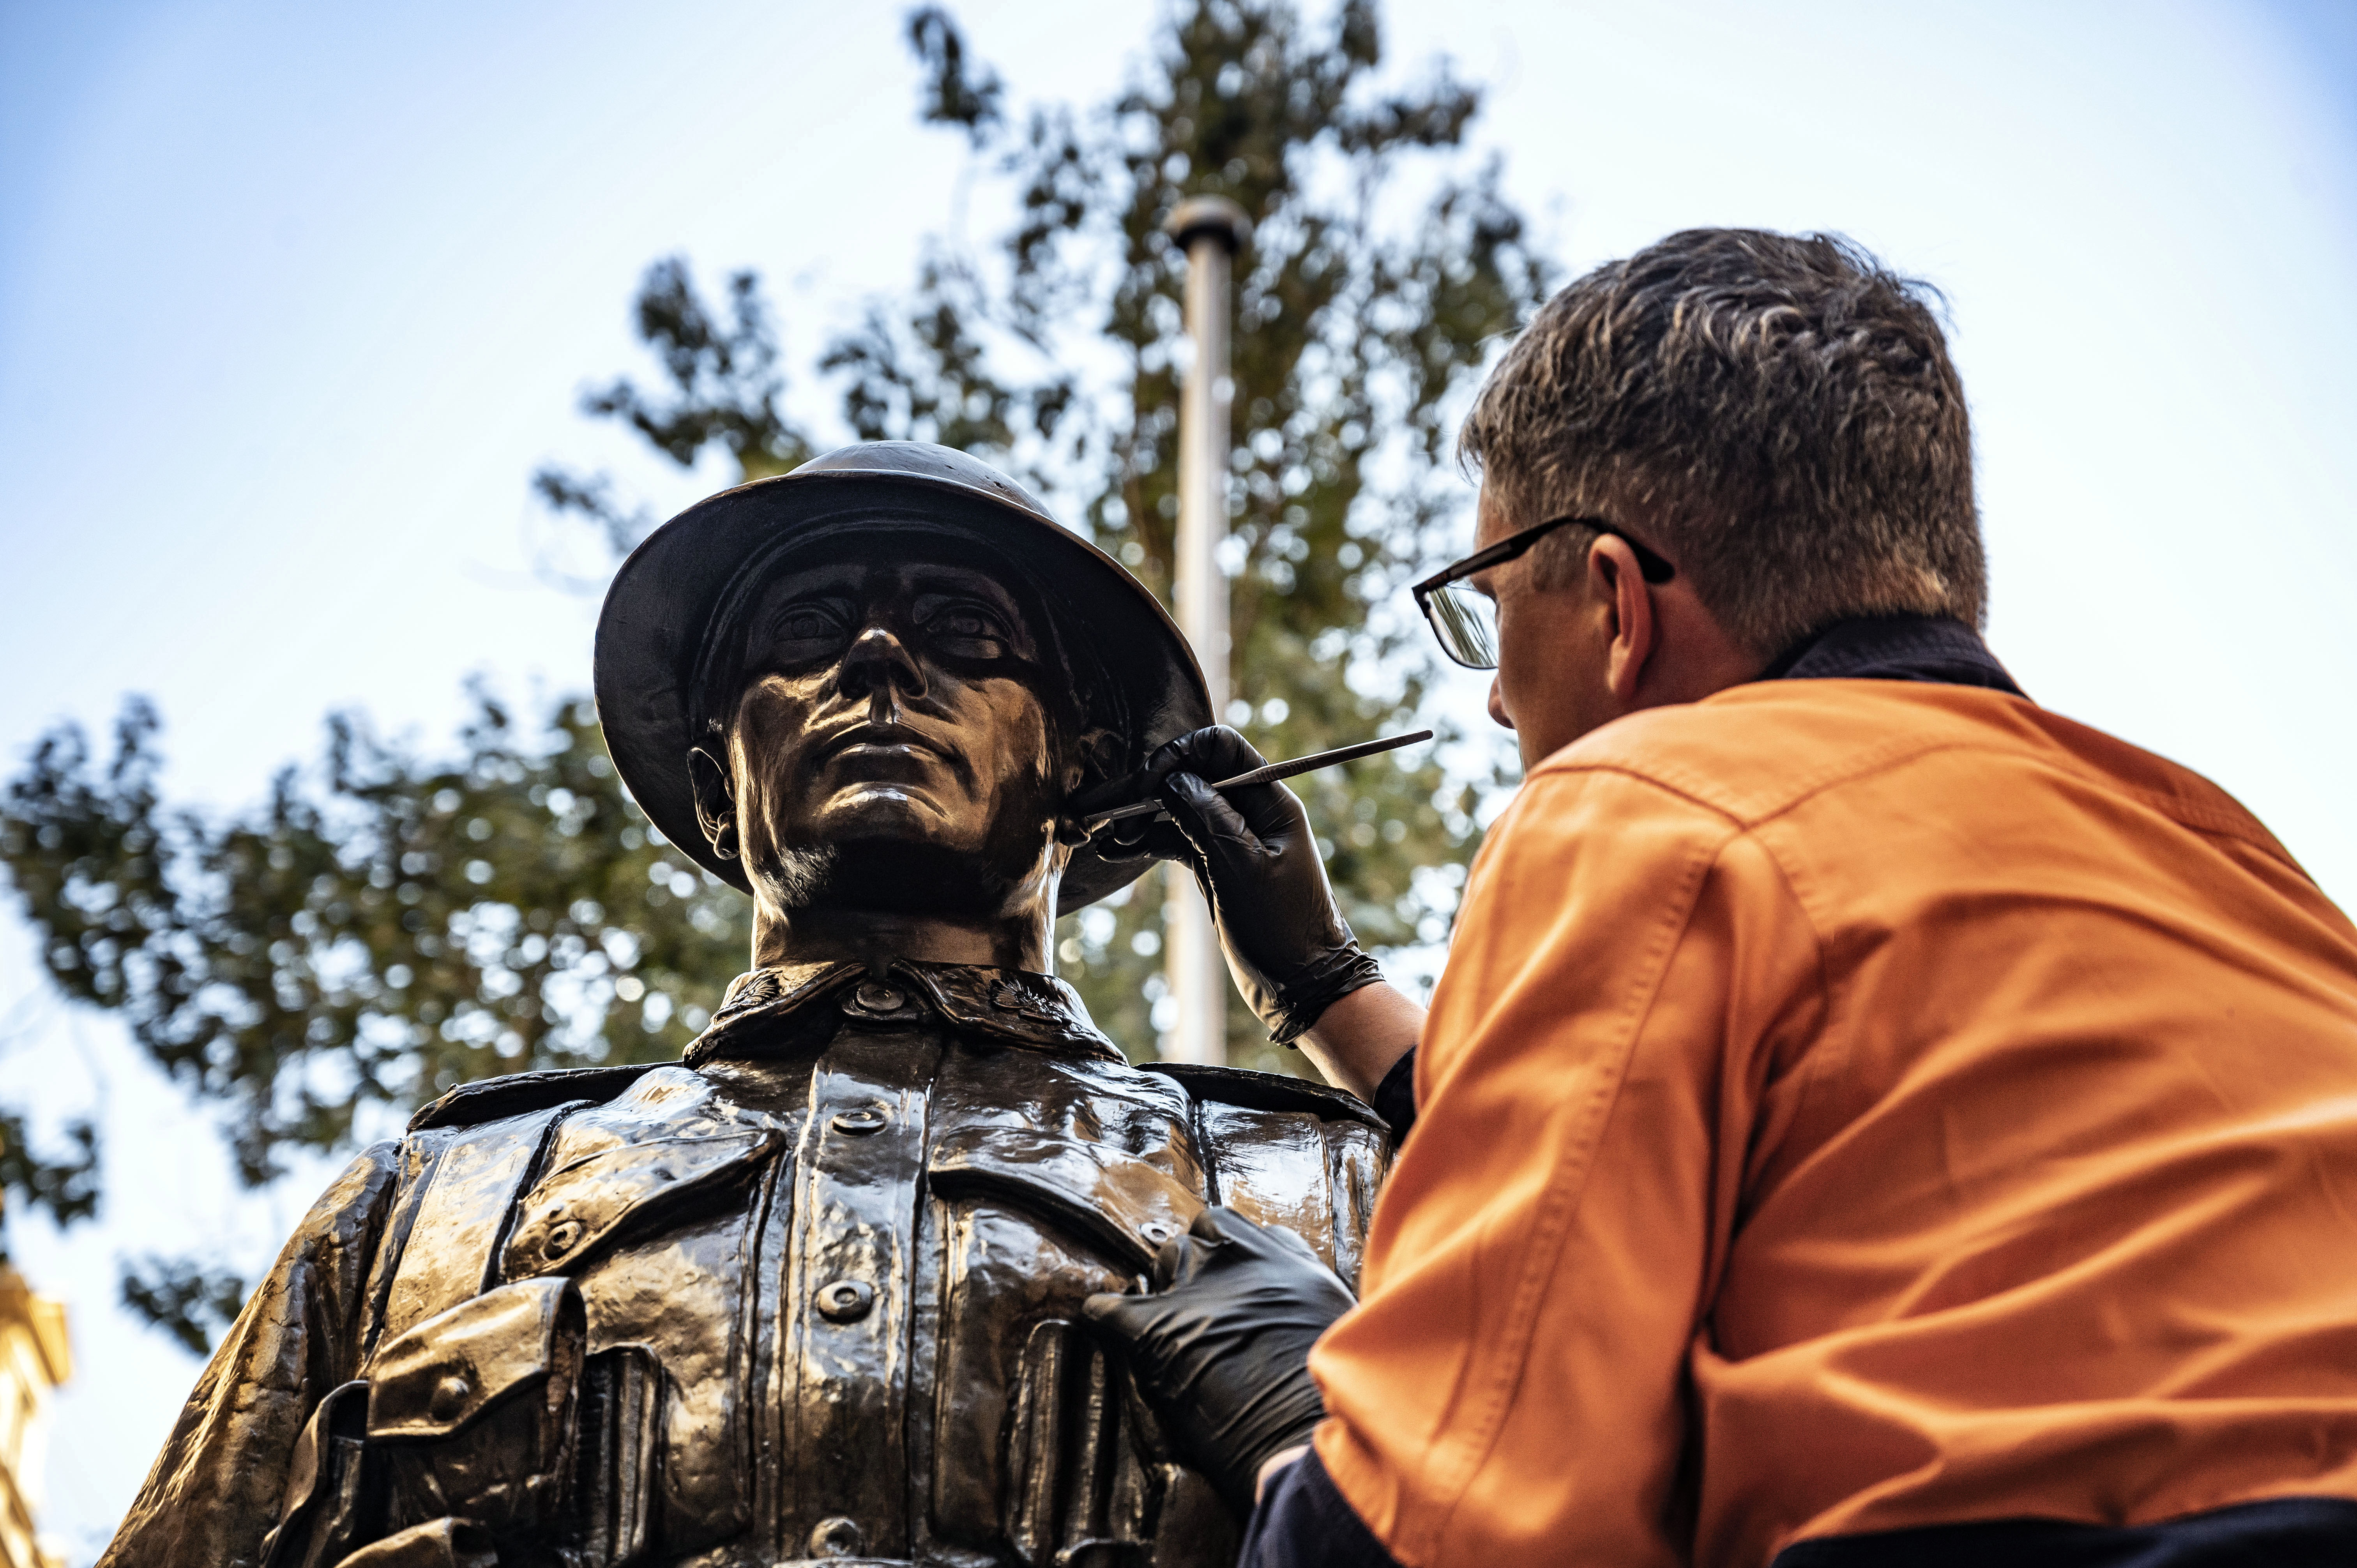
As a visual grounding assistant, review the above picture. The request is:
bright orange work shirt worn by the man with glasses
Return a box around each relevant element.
[1311,679,2357,1568]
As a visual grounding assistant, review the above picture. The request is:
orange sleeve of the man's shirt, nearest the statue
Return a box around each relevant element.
[1311,766,1822,1568]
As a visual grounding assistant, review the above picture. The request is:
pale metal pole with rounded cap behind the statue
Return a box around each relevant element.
[1162,196,1249,1063]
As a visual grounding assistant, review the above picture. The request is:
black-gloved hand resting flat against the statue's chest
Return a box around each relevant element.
[1080,1202,1358,1514]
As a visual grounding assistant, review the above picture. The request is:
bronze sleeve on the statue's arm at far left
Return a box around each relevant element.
[99,1144,401,1568]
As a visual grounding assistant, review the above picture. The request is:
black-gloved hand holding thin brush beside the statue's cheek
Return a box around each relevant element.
[1106,724,1383,1045]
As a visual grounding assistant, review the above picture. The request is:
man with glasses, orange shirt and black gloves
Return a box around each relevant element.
[1089,229,2357,1568]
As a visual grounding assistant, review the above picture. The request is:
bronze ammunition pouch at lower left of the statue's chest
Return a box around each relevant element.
[261,1278,662,1568]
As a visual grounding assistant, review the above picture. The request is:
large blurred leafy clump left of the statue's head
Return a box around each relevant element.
[0,698,749,1179]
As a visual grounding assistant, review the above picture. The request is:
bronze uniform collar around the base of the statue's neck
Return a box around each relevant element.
[686,957,1124,1066]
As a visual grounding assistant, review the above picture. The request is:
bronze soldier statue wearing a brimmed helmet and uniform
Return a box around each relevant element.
[106,443,1388,1568]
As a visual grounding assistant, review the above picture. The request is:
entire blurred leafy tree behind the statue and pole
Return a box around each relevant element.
[0,0,1549,1344]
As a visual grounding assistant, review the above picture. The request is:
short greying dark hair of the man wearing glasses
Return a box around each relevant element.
[1457,229,1987,658]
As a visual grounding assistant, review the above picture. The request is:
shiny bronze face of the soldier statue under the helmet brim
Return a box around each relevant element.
[702,547,1080,915]
